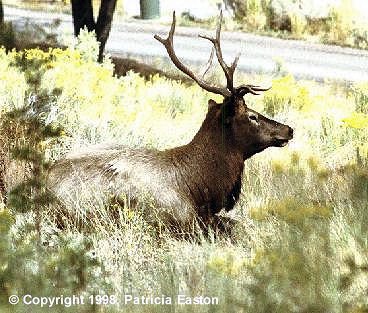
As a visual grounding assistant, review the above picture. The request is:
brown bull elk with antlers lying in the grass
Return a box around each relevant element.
[49,12,293,232]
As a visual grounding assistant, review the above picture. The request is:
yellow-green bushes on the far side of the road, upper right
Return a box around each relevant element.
[224,0,368,49]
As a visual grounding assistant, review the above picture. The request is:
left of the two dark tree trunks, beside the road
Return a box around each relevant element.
[69,0,96,37]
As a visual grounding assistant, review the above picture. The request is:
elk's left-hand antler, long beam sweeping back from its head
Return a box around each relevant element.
[154,11,231,97]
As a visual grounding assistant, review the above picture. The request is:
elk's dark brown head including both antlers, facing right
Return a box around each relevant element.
[154,11,293,158]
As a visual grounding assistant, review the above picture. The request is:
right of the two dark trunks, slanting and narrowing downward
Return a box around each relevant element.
[96,0,117,62]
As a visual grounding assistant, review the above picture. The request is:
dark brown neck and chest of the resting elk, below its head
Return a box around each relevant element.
[162,119,244,216]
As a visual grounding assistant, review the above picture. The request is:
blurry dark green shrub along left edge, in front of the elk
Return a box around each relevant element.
[0,32,110,312]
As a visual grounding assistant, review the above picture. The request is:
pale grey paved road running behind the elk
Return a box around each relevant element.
[4,7,368,81]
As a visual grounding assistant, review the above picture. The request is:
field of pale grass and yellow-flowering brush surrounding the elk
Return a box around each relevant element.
[0,29,368,313]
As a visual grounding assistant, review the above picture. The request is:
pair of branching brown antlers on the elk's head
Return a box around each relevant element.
[154,11,270,98]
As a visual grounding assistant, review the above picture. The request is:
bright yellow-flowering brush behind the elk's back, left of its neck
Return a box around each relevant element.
[0,43,216,152]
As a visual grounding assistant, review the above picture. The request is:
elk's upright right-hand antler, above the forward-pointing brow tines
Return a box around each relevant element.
[199,10,240,93]
